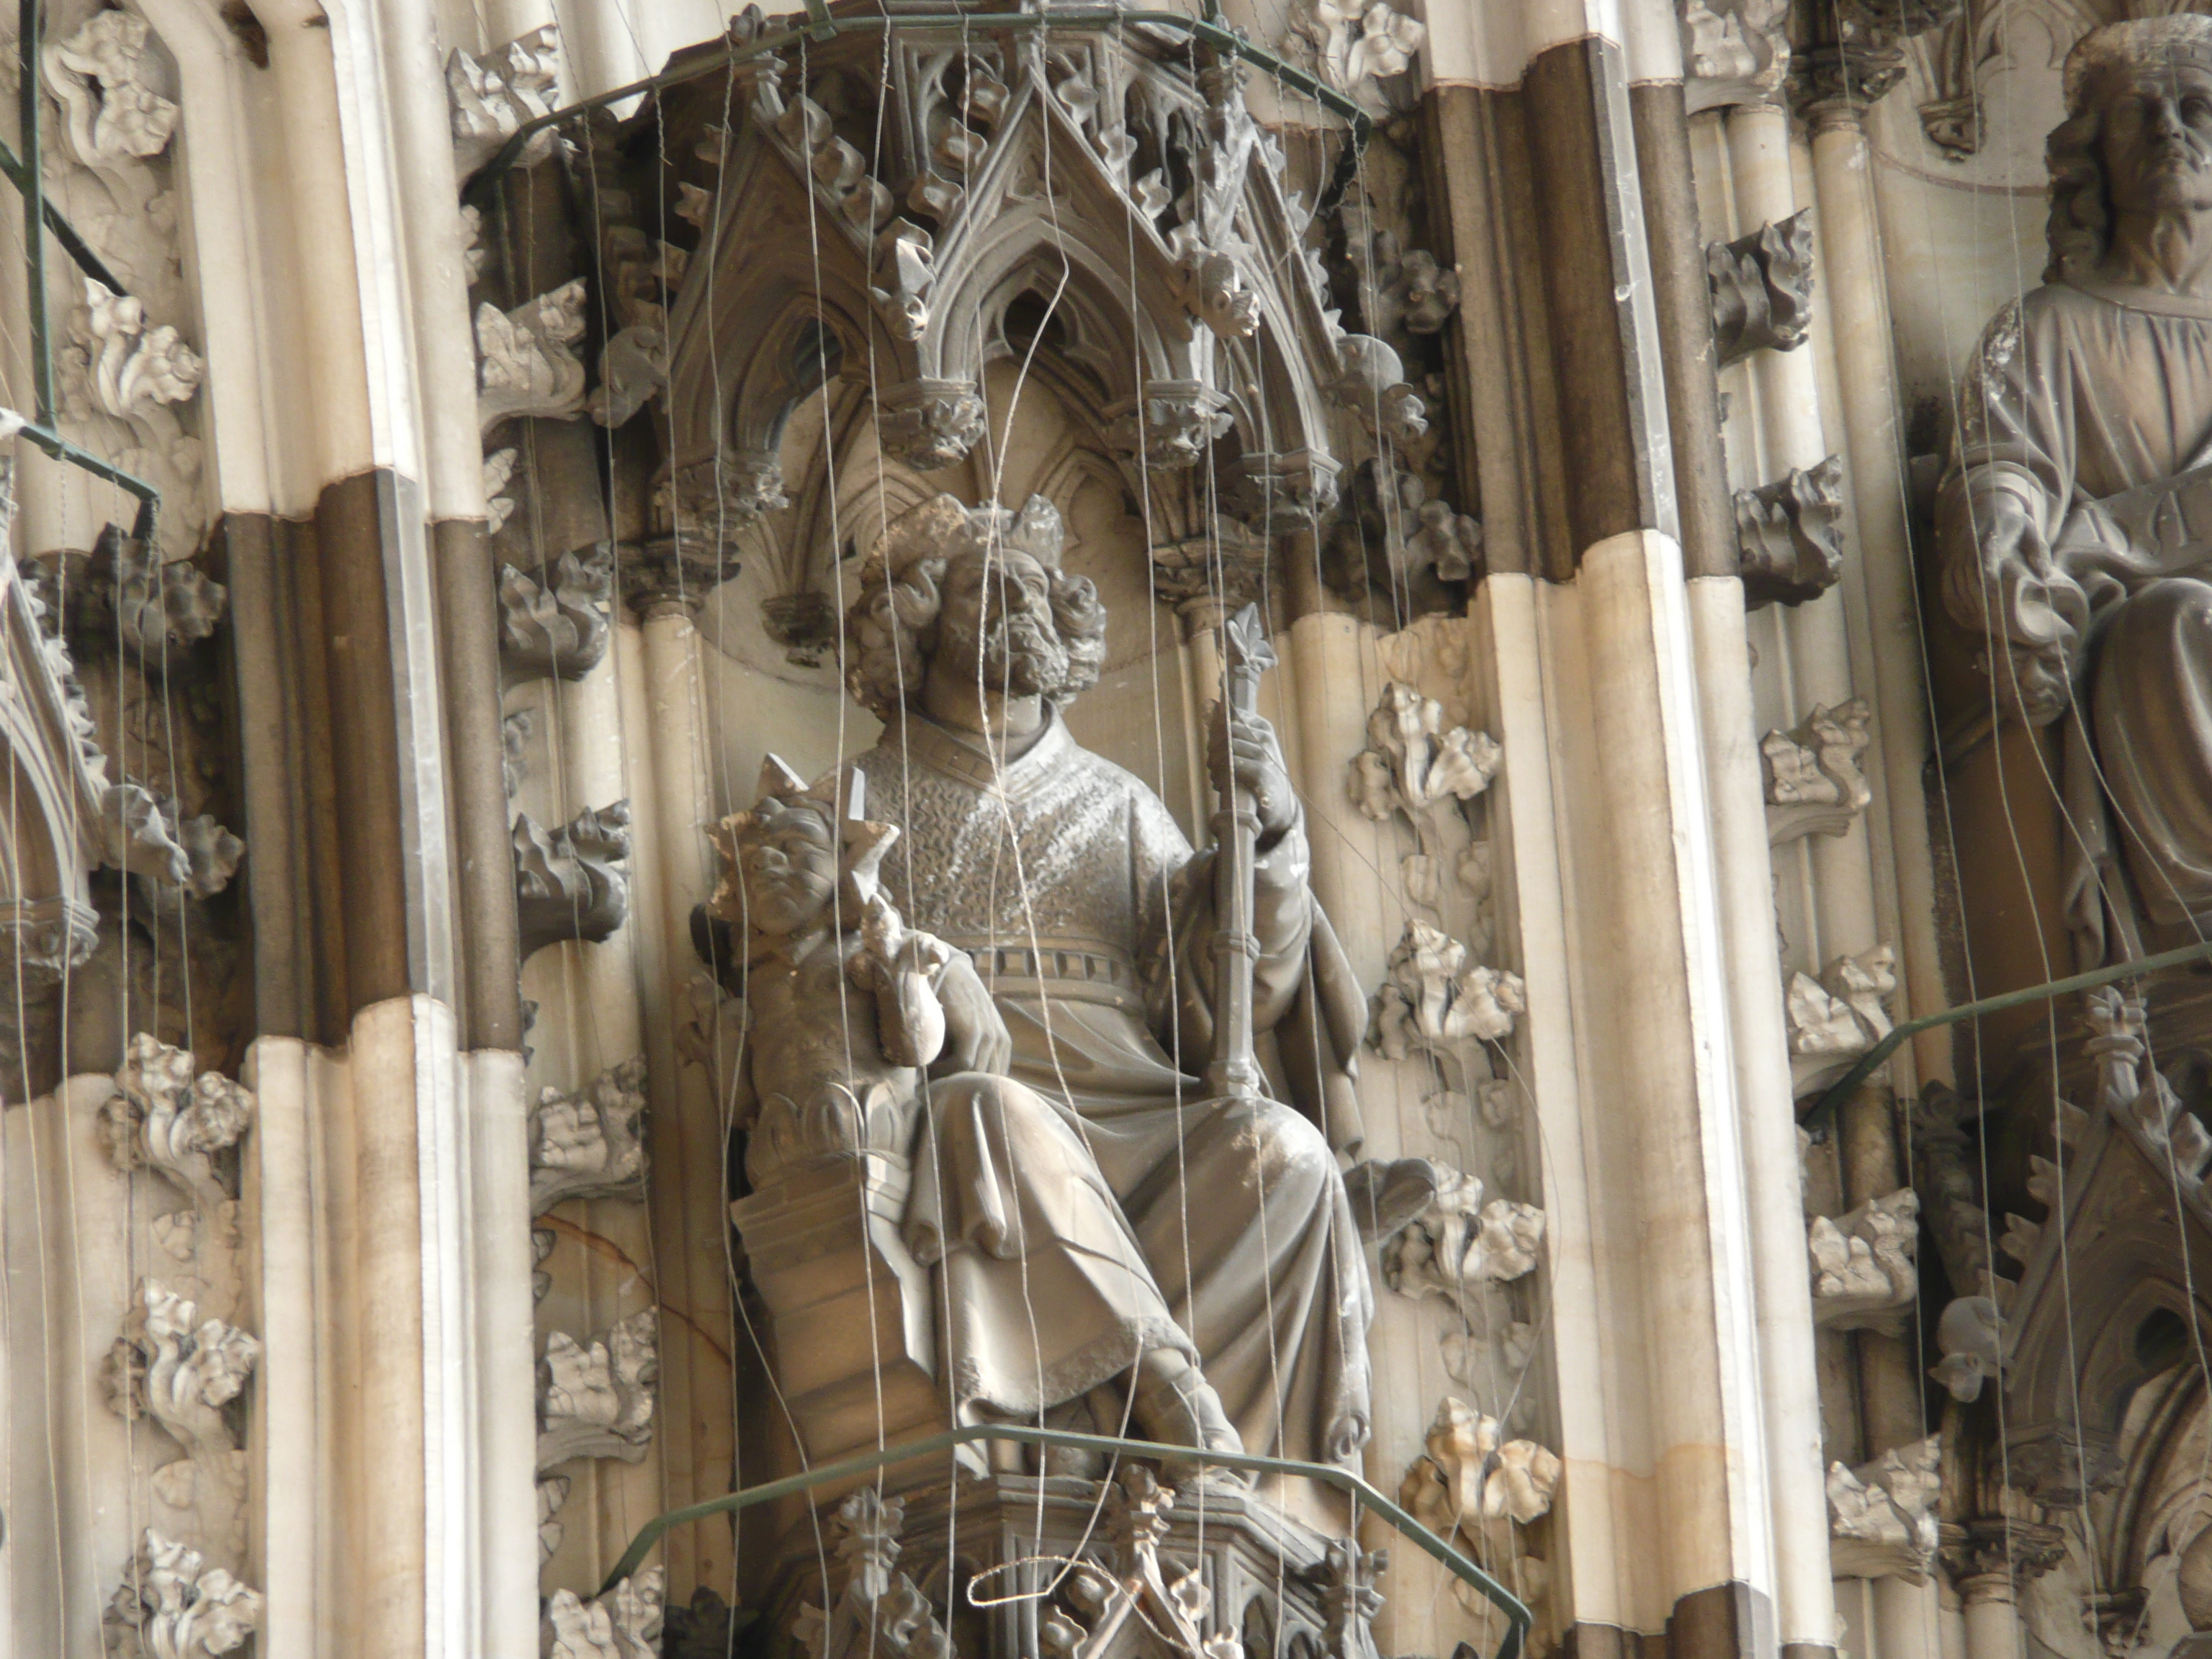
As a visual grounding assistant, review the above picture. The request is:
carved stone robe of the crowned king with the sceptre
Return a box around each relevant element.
[836,714,1374,1460]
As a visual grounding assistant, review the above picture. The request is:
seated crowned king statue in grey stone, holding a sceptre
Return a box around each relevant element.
[710,495,1372,1462]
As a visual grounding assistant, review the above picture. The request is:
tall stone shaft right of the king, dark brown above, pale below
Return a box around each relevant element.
[1429,6,1778,1655]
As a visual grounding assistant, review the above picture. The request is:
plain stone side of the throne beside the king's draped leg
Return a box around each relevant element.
[730,1153,951,1500]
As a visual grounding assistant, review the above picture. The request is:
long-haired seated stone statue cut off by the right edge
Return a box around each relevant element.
[1938,16,2212,964]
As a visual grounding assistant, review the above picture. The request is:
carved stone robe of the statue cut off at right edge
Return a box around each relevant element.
[1940,281,2212,964]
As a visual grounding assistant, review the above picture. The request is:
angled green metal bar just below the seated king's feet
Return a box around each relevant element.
[600,1422,1535,1659]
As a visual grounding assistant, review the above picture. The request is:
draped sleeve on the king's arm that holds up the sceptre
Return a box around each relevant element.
[1130,799,1367,1153]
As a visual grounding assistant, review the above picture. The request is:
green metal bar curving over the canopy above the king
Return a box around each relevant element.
[459,0,1374,215]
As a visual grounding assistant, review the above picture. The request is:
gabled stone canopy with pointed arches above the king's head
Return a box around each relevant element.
[666,27,1416,579]
